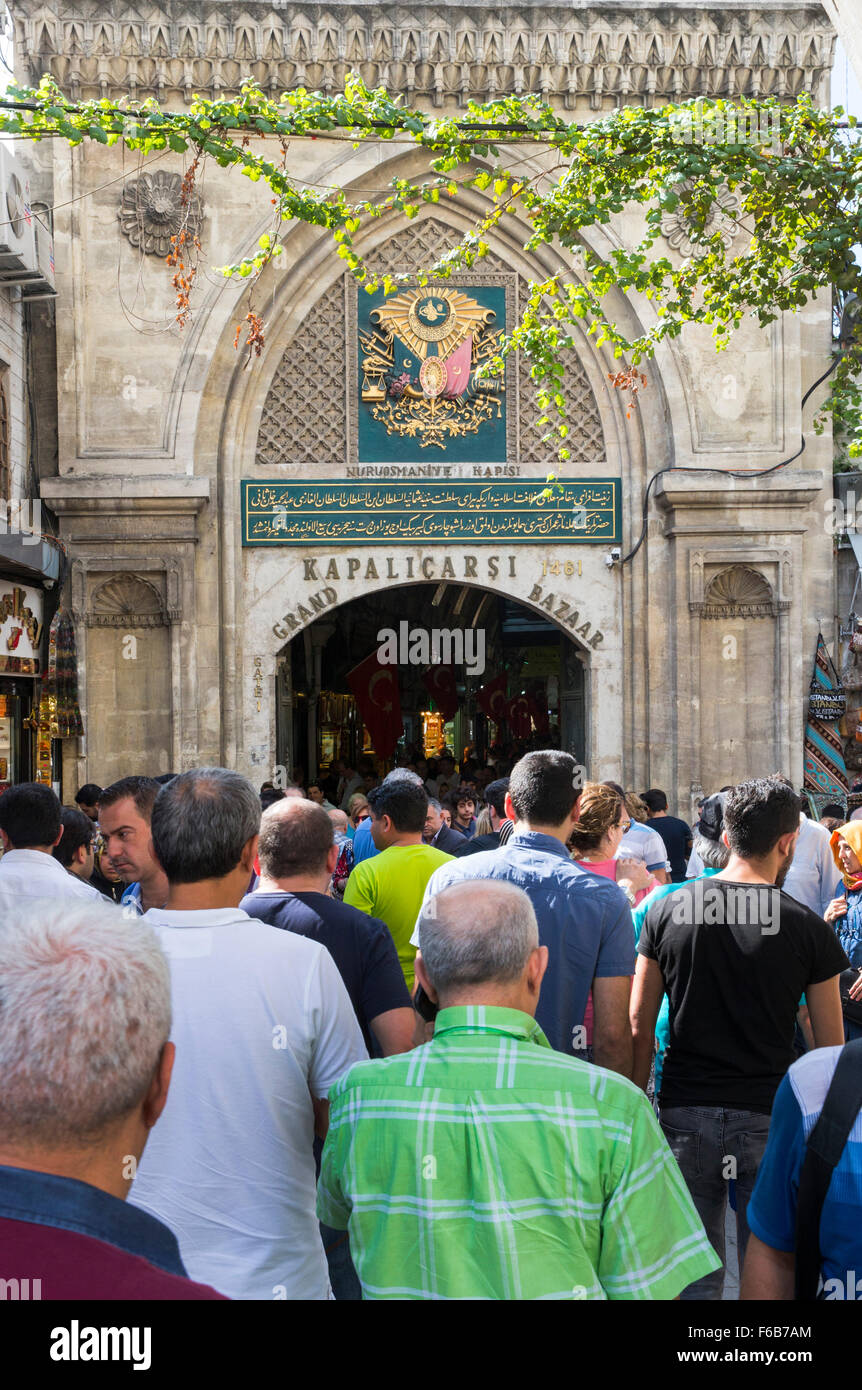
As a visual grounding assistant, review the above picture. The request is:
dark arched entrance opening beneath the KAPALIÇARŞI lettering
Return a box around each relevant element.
[277,582,585,781]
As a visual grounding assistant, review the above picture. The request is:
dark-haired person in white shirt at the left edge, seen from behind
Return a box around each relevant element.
[0,783,104,910]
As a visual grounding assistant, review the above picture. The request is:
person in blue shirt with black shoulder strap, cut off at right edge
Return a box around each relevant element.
[740,1047,862,1300]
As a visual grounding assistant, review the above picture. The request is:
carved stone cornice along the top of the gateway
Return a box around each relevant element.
[10,0,834,111]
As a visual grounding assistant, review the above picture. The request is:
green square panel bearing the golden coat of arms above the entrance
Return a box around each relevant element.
[355,284,506,463]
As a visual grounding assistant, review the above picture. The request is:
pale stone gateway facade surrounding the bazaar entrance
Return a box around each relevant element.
[14,0,834,815]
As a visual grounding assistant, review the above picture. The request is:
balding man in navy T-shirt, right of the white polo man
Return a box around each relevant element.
[241,796,414,1056]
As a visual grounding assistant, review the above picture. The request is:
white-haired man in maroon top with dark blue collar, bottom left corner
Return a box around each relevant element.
[0,895,221,1295]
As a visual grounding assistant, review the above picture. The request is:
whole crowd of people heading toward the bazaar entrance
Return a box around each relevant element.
[0,748,862,1300]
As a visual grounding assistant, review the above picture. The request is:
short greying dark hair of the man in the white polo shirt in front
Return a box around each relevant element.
[152,767,260,883]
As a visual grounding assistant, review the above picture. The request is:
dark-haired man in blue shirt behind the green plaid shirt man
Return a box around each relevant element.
[413,749,635,1077]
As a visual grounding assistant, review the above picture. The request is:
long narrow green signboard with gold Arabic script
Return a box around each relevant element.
[242,478,621,546]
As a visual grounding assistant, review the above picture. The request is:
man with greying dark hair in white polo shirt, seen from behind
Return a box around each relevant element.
[129,767,367,1301]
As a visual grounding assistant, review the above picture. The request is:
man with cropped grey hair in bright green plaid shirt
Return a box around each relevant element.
[317,880,720,1298]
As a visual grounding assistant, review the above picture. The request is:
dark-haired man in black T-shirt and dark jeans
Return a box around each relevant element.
[631,778,847,1300]
